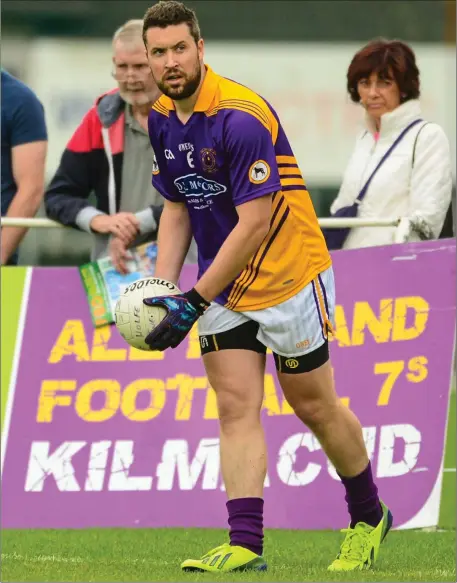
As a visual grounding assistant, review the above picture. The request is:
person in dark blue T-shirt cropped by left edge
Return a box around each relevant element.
[0,69,48,265]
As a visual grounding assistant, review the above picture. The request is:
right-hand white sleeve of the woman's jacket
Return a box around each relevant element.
[409,124,452,239]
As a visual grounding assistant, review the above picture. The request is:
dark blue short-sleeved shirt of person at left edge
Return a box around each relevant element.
[2,69,48,216]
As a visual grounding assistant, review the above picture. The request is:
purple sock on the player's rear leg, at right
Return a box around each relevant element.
[340,462,382,528]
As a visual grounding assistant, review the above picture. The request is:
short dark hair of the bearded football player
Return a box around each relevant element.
[143,0,201,45]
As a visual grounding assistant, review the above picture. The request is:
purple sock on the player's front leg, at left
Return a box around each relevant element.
[227,498,263,555]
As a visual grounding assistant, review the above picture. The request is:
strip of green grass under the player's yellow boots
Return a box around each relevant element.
[1,529,456,582]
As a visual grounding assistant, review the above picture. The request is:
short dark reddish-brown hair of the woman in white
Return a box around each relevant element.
[347,38,420,103]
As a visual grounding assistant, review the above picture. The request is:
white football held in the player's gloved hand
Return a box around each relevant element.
[114,277,181,350]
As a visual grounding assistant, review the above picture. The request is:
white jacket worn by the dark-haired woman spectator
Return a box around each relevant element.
[330,100,452,249]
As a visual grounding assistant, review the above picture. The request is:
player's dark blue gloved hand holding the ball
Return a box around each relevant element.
[143,289,210,351]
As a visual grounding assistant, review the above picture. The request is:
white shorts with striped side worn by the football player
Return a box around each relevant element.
[198,267,335,356]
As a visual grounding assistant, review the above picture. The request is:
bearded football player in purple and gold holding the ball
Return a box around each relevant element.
[143,1,392,572]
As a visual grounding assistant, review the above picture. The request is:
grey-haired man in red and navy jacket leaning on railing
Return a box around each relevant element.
[45,20,163,273]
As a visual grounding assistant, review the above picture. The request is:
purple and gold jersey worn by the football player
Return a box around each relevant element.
[149,66,331,311]
